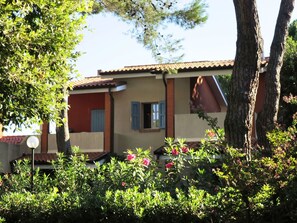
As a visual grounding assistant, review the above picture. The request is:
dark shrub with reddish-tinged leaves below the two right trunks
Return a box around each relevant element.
[209,112,297,222]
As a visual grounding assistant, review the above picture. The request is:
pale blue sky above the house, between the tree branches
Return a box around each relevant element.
[76,0,297,77]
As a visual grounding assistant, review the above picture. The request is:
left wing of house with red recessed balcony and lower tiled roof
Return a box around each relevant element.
[42,76,126,153]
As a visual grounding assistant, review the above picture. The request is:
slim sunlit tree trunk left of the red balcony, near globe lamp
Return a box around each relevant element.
[56,89,72,156]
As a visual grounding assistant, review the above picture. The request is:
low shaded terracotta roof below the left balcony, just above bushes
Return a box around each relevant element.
[16,152,108,164]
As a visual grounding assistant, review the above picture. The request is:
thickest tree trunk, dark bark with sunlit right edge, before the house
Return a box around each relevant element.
[225,0,263,158]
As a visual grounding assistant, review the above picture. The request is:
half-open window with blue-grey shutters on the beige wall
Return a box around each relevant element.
[131,101,165,130]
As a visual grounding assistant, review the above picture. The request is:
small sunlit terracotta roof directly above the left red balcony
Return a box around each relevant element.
[72,76,125,90]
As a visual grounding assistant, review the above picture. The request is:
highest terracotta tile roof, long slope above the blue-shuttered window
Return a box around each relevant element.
[99,58,267,75]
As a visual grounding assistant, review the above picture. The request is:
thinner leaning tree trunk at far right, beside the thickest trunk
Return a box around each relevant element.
[256,0,295,152]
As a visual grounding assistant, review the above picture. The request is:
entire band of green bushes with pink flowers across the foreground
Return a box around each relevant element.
[0,114,297,223]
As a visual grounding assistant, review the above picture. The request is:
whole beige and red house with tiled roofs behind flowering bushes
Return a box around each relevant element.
[42,60,267,154]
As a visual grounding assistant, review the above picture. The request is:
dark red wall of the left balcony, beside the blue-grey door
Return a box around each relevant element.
[68,93,105,132]
